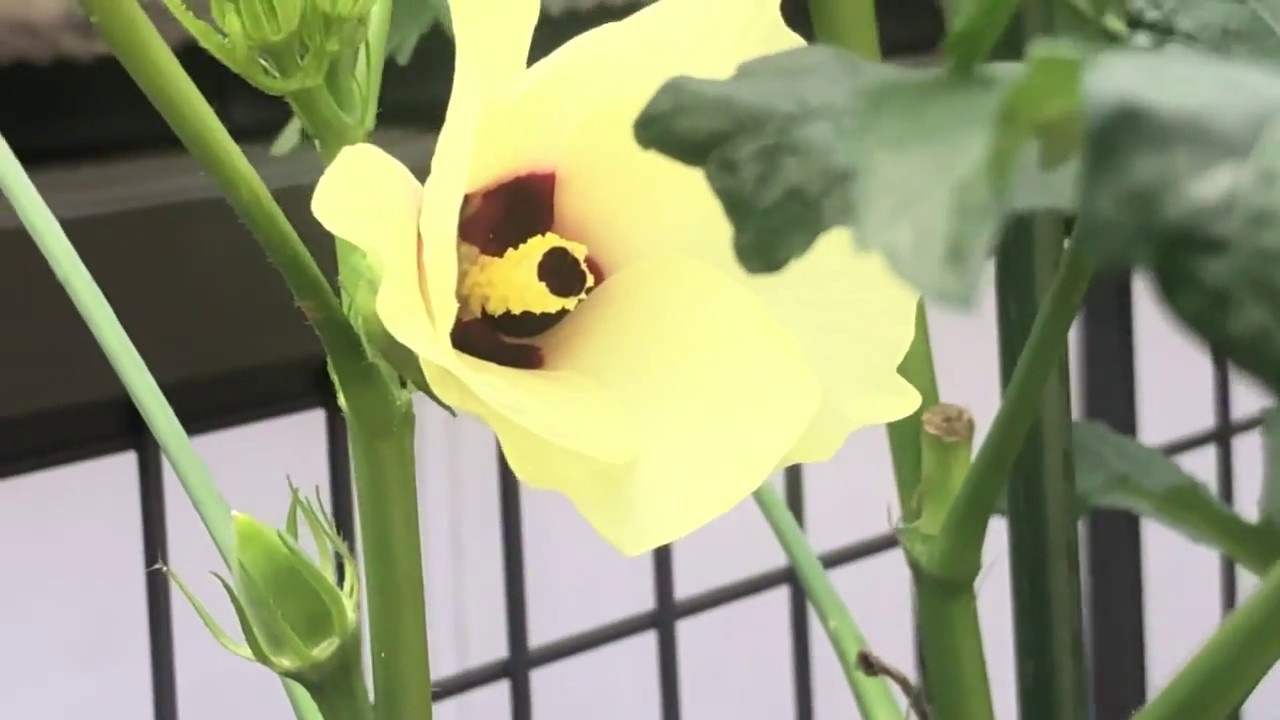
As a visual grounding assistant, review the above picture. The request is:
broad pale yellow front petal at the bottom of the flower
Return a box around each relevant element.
[497,256,820,555]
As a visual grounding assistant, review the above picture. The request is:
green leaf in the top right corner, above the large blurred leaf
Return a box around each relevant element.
[1132,0,1280,63]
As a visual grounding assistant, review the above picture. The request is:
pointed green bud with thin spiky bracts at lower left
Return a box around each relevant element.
[169,489,360,688]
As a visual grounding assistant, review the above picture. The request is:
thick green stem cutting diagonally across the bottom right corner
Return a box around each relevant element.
[1133,558,1280,720]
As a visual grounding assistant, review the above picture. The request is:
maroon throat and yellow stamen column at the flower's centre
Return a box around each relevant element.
[452,173,603,369]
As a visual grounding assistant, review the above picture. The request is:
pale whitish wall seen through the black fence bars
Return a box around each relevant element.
[0,266,1280,720]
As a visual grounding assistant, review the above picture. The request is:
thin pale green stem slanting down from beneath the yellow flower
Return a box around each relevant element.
[755,483,902,720]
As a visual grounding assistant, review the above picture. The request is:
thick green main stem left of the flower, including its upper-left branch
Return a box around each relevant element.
[83,0,419,720]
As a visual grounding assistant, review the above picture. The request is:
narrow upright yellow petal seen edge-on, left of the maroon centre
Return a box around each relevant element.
[420,0,541,337]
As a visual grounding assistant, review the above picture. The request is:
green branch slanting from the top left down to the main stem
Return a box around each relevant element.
[82,0,366,386]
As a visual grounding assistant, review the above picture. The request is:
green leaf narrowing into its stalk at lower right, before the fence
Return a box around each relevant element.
[1073,421,1280,573]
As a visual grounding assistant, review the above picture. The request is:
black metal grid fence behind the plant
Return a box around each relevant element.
[0,271,1261,720]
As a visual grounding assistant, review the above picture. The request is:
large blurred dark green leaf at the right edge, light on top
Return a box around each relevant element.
[1076,49,1280,389]
